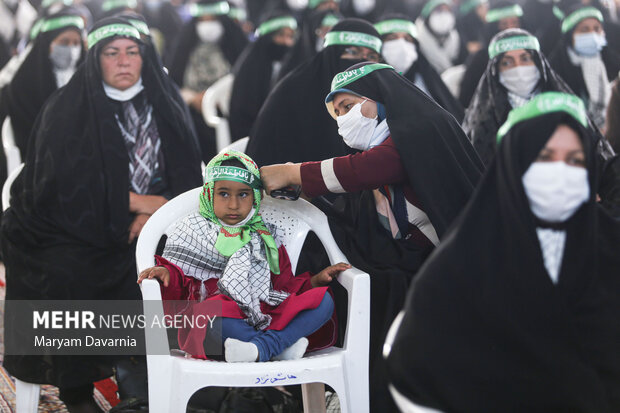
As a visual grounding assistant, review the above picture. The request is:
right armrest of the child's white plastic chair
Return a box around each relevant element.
[337,268,370,360]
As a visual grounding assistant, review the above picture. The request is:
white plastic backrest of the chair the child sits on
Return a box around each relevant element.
[136,187,347,271]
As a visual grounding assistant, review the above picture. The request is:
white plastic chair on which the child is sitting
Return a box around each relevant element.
[136,188,370,413]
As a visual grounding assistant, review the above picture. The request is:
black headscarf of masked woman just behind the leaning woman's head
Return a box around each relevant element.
[377,13,464,122]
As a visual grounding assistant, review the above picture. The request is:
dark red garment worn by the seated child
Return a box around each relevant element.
[155,246,338,358]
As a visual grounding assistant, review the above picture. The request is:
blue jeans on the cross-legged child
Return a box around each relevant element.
[222,293,334,361]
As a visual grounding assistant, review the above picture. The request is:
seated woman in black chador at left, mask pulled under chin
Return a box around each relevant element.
[2,17,201,412]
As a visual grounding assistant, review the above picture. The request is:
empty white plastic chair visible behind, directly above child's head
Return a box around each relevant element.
[202,73,235,152]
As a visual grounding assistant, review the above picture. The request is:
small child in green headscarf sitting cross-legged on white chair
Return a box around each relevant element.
[138,151,350,362]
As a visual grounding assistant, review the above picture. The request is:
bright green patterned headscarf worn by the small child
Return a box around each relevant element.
[200,151,280,274]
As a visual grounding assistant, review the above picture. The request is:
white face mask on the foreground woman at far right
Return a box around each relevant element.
[522,161,590,222]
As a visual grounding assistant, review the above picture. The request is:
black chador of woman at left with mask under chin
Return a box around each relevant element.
[1,18,202,387]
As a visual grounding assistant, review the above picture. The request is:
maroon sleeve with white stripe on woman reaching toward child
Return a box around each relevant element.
[300,137,407,197]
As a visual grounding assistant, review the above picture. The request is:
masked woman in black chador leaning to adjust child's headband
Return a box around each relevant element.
[261,62,482,411]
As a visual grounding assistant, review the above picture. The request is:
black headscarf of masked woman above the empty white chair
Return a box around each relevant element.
[166,0,248,87]
